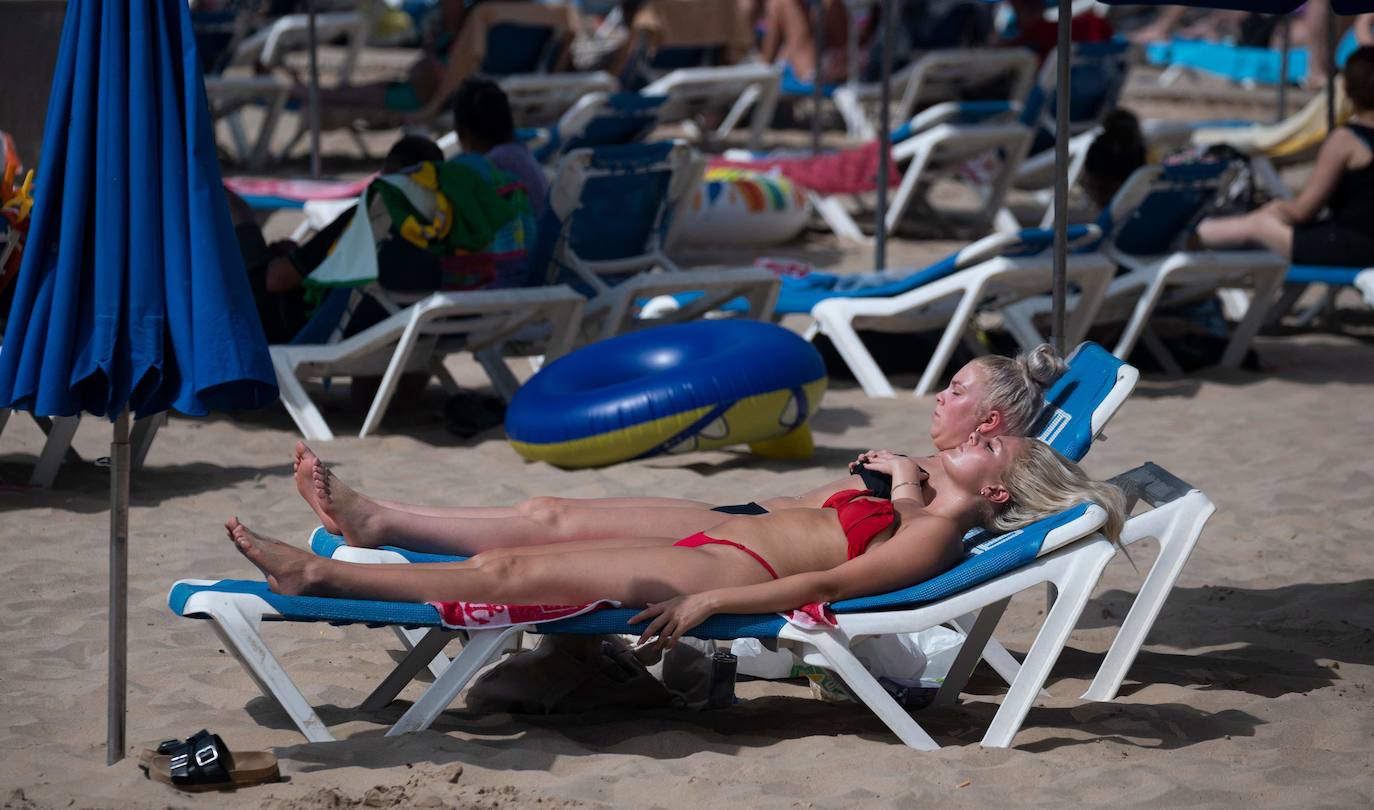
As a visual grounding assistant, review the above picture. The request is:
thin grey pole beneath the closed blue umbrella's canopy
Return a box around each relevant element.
[104,410,129,765]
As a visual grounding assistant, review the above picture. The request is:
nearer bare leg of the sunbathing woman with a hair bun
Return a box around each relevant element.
[302,459,728,555]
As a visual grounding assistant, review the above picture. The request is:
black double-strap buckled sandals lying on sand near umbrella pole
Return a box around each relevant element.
[139,729,282,792]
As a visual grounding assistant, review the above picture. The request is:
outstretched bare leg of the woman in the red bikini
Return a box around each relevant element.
[225,518,768,605]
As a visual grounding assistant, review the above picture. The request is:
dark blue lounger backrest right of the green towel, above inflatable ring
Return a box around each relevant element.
[526,141,695,292]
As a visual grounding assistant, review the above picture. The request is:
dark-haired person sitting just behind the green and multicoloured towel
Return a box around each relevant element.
[453,78,548,217]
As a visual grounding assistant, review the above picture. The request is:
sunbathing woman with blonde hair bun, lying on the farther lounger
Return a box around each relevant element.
[295,345,1066,555]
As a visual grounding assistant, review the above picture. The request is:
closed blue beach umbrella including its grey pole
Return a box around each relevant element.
[0,0,276,762]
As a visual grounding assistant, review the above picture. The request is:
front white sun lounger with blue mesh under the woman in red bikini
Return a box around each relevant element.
[168,504,1116,751]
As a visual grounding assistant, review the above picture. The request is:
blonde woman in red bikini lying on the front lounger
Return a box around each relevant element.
[225,432,1123,647]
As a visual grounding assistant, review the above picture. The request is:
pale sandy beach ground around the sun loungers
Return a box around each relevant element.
[0,35,1374,810]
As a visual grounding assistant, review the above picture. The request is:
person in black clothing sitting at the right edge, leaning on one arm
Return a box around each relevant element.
[1197,45,1374,268]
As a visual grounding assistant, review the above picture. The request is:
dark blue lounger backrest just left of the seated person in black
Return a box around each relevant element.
[1098,162,1237,255]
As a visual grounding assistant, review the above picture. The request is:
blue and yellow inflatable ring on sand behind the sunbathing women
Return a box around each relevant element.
[506,320,826,468]
